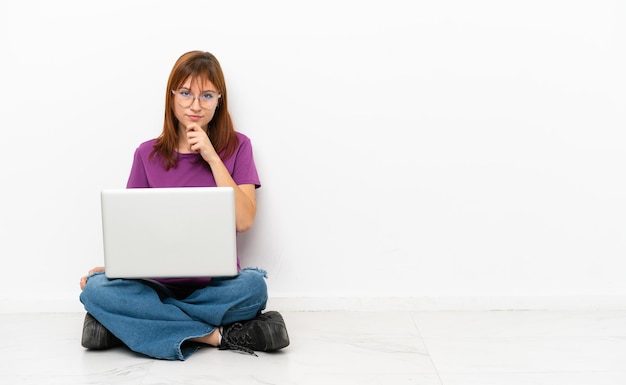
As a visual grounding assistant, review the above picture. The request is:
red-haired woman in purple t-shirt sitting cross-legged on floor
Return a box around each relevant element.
[80,51,289,360]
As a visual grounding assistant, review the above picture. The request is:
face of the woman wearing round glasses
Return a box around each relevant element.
[173,77,220,131]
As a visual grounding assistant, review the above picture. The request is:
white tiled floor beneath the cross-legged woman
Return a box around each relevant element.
[0,311,626,385]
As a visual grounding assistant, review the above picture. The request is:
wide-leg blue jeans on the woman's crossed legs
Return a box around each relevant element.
[80,268,267,360]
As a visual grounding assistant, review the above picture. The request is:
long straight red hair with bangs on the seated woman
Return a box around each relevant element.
[150,51,239,170]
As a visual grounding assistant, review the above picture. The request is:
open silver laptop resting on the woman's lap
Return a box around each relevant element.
[101,187,237,278]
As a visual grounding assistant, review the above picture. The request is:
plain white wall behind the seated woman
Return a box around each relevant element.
[0,0,626,311]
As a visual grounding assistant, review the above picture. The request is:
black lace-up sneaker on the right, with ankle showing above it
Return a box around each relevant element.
[219,311,289,355]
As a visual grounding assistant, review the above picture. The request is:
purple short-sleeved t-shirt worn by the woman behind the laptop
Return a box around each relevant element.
[126,132,261,293]
